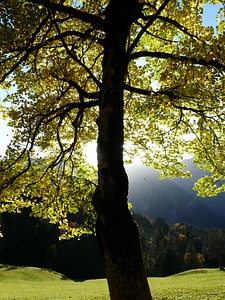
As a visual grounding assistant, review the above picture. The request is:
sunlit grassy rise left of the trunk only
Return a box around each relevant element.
[0,264,109,300]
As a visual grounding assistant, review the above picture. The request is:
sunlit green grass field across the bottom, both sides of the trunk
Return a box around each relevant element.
[0,265,225,300]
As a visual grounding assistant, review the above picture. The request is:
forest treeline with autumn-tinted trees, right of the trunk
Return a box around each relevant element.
[134,214,225,276]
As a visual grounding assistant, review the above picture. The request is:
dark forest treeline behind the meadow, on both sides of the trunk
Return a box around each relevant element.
[0,210,225,279]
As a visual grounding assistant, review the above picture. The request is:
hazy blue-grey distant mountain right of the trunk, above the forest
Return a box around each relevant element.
[126,159,225,228]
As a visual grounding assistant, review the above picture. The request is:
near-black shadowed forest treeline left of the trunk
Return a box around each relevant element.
[0,209,104,279]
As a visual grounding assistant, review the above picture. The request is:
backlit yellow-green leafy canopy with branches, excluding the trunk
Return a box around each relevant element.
[0,0,225,236]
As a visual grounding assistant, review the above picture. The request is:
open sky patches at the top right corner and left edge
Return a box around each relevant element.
[0,4,222,155]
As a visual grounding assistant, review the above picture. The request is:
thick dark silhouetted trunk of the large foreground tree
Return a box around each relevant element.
[93,0,152,300]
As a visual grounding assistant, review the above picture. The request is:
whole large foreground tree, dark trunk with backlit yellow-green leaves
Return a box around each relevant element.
[0,0,225,300]
